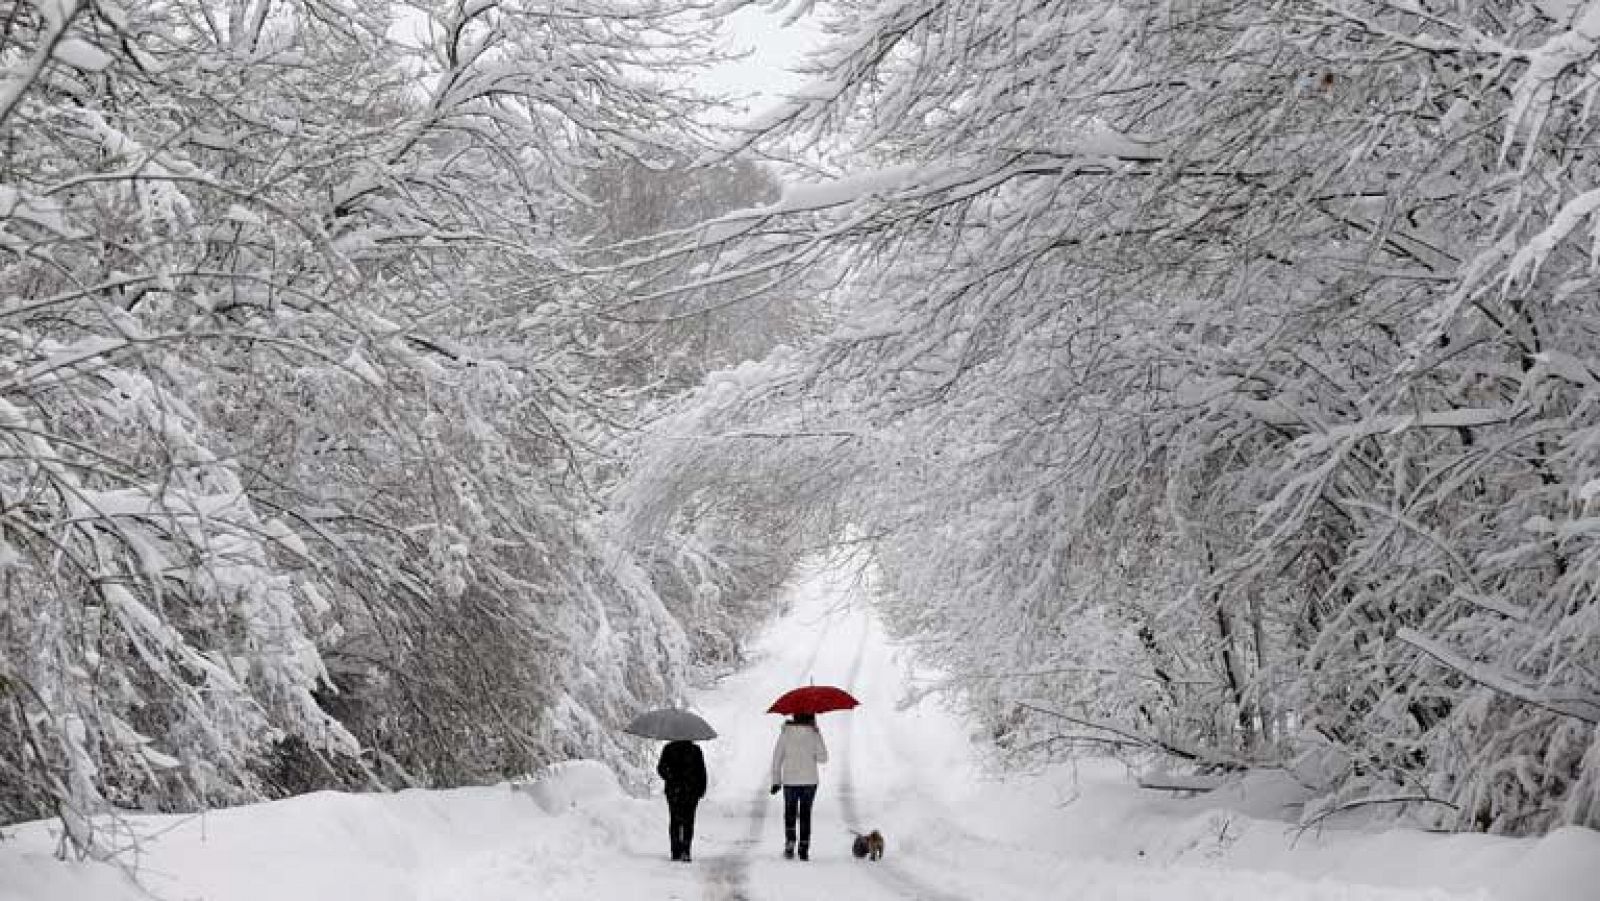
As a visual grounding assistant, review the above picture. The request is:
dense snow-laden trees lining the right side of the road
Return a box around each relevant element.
[637,0,1600,832]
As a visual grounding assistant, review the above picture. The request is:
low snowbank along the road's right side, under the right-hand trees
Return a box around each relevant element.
[978,760,1600,901]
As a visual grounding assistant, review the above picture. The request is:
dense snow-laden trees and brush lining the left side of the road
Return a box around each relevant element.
[0,0,787,851]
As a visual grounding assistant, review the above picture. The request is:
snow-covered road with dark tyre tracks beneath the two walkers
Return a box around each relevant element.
[678,570,1478,901]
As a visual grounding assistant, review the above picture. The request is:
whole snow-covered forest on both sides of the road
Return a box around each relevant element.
[0,0,1600,856]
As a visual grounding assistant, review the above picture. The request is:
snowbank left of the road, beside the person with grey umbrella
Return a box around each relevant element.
[0,760,664,901]
